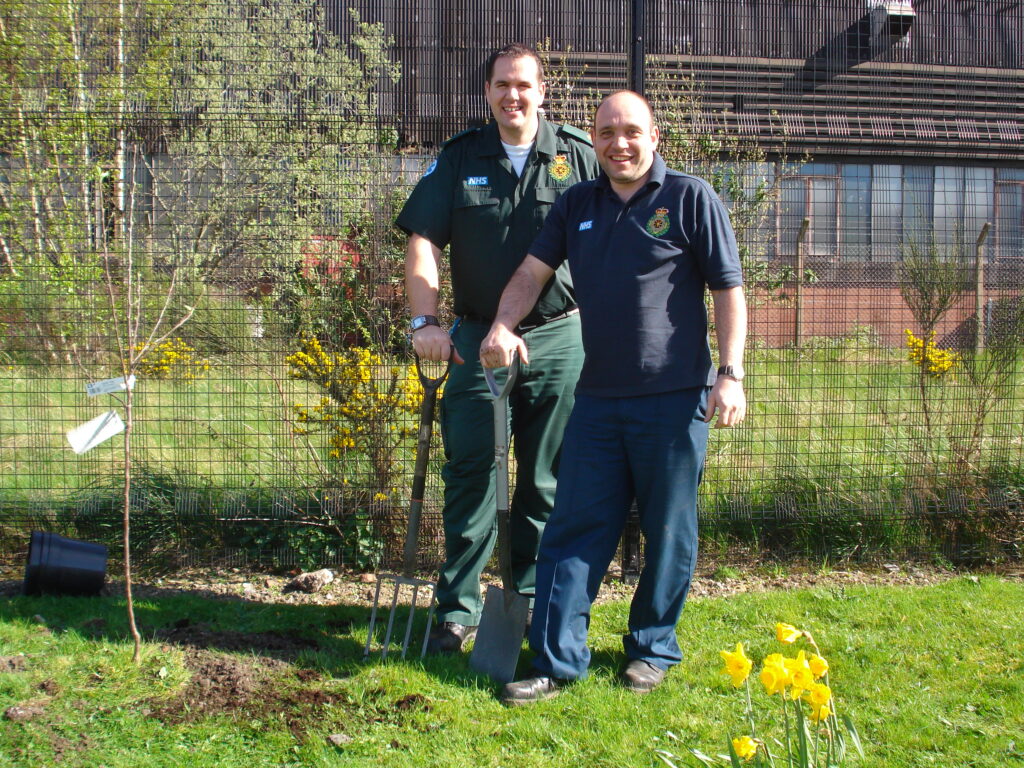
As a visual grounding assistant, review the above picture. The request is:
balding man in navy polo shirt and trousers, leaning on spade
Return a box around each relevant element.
[480,91,746,705]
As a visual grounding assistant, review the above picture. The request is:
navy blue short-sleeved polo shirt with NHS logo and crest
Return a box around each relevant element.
[529,153,742,397]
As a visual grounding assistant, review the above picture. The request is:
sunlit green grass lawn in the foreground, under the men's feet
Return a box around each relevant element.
[0,577,1024,768]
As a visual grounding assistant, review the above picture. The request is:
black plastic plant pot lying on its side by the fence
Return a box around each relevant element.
[25,530,106,595]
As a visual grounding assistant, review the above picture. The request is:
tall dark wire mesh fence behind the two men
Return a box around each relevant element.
[0,0,1024,568]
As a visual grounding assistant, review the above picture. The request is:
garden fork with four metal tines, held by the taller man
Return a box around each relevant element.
[362,354,454,659]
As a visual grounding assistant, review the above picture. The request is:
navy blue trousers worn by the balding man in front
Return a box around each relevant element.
[529,387,710,680]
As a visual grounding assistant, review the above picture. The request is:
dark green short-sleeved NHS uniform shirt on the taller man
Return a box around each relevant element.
[397,118,598,326]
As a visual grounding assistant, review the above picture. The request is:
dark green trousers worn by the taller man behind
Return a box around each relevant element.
[437,314,583,626]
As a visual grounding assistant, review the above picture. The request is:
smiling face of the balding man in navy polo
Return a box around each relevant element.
[591,91,660,199]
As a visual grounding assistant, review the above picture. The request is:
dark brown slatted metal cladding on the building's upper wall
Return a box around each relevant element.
[328,0,1024,162]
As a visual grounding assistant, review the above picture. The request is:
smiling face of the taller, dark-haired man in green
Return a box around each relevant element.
[483,56,544,145]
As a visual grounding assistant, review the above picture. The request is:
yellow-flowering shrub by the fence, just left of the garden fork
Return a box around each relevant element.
[285,336,423,502]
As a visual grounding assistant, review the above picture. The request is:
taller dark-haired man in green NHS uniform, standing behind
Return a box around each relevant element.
[397,44,598,653]
